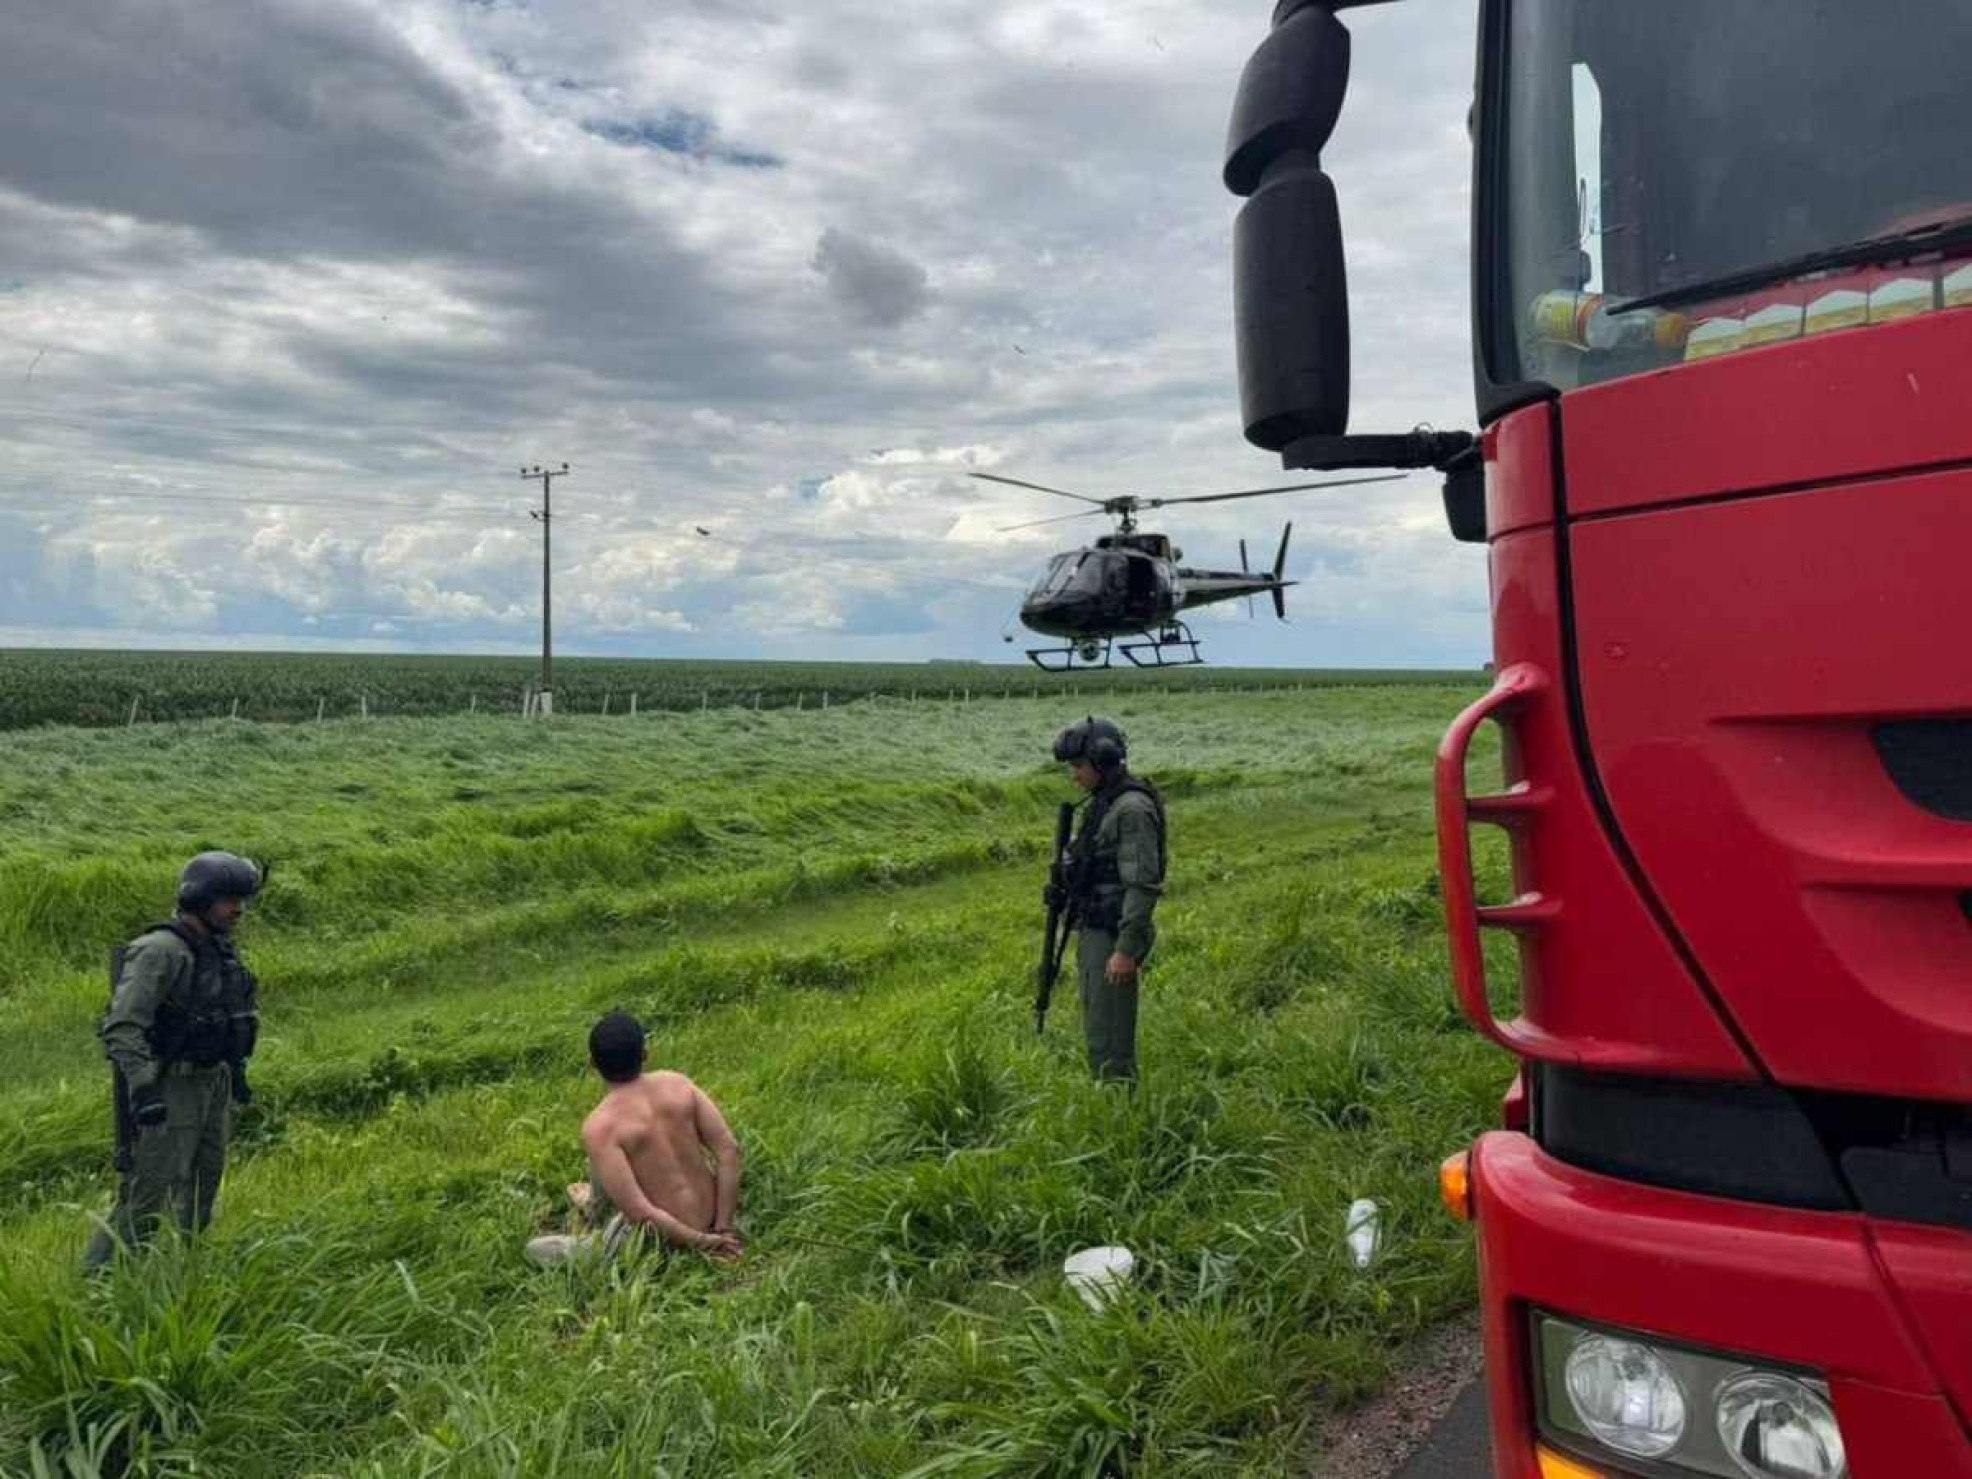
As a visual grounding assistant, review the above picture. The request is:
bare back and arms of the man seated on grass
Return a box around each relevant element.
[582,1073,741,1256]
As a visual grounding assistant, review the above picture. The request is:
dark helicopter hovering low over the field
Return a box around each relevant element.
[972,473,1400,672]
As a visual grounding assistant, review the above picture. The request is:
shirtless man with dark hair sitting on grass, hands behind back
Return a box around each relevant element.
[527,1012,743,1264]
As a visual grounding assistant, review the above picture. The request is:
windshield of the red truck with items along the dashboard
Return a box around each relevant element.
[1491,0,1972,388]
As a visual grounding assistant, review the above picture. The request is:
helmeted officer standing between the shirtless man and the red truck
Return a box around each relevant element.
[1055,716,1165,1083]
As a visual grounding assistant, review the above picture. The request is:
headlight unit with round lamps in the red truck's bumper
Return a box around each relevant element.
[1532,1311,1848,1479]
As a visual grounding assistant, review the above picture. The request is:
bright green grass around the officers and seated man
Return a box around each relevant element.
[0,690,1511,1479]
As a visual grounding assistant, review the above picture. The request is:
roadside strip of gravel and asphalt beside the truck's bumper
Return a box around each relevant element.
[1309,1319,1493,1479]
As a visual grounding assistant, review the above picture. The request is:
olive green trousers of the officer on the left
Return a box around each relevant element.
[83,1063,233,1268]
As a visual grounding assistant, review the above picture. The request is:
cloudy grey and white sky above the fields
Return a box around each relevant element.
[0,0,1489,665]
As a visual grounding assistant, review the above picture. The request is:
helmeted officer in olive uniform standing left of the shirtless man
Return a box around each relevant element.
[83,852,264,1268]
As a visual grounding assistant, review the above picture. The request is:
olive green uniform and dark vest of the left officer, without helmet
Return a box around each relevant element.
[83,929,258,1268]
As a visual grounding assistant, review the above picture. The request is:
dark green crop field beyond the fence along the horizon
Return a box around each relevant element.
[0,649,1467,730]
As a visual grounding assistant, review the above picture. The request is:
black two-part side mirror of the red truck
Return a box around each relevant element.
[1225,0,1349,452]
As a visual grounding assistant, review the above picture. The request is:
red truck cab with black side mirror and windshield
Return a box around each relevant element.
[1225,0,1972,1479]
